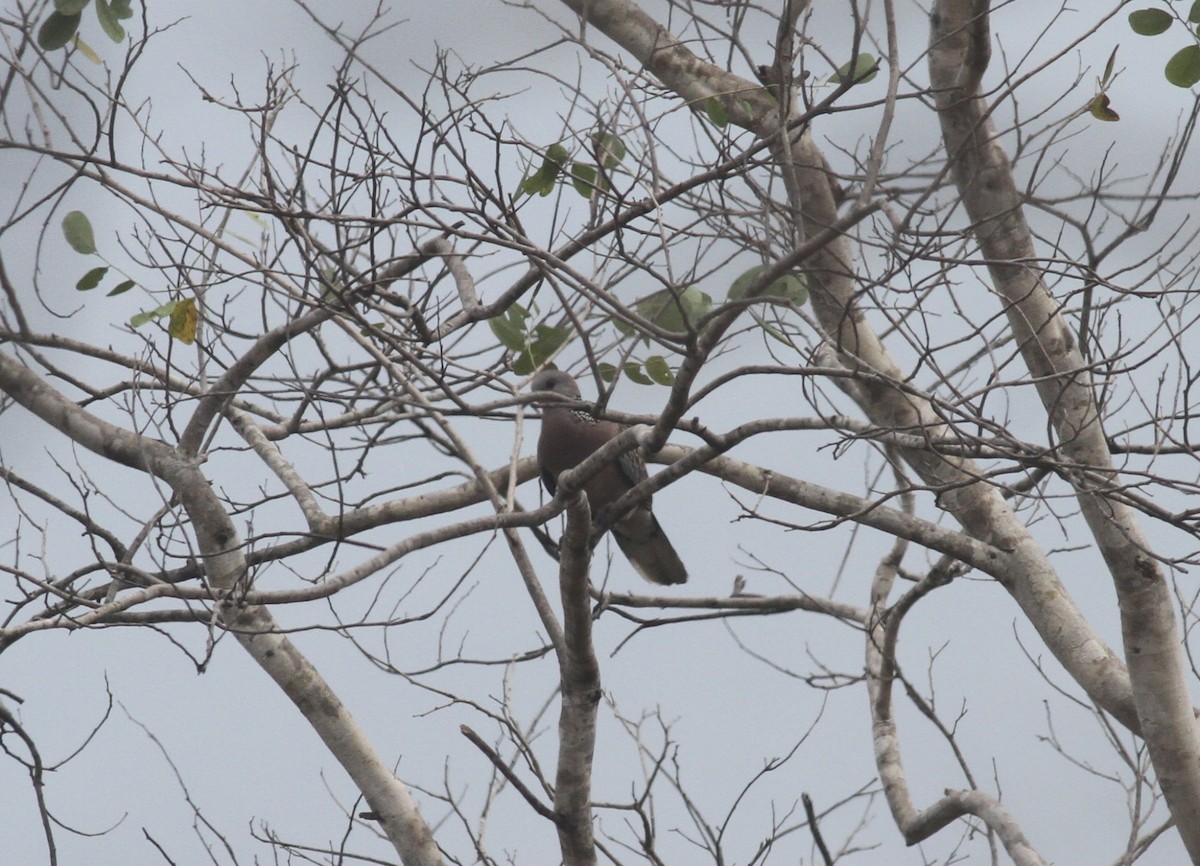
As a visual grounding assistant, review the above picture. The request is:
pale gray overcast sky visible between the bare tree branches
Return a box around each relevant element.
[0,0,1190,866]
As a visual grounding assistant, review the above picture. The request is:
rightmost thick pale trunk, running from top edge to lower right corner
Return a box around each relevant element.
[929,0,1200,862]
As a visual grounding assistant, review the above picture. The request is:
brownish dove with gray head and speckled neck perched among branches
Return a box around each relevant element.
[529,369,688,584]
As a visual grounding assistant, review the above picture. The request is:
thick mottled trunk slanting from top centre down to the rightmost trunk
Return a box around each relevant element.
[554,0,1139,730]
